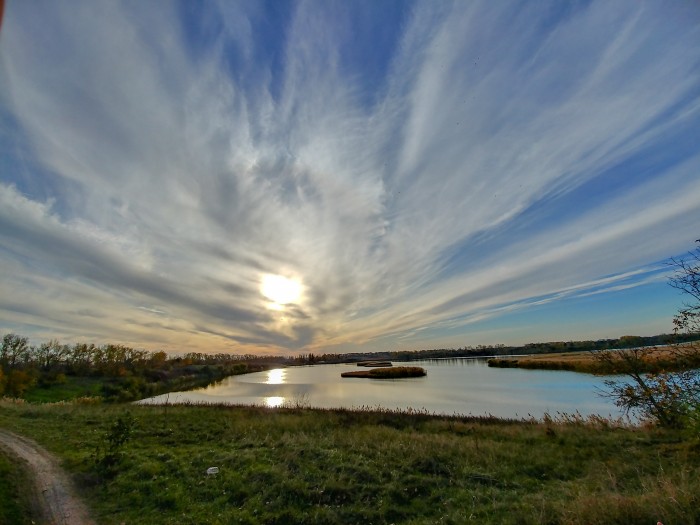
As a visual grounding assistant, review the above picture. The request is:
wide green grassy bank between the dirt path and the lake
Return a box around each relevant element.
[0,402,700,525]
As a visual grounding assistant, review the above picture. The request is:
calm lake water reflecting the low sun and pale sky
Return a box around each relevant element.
[135,359,621,418]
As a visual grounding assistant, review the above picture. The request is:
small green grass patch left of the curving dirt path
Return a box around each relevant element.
[0,449,34,525]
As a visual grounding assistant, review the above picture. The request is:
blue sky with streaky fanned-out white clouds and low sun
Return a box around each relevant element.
[0,0,700,355]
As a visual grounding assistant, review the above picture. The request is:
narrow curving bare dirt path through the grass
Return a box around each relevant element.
[0,429,94,525]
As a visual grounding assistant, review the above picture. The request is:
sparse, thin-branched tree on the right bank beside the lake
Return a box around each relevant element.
[594,240,700,428]
